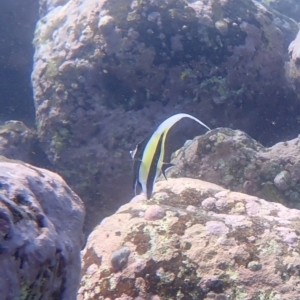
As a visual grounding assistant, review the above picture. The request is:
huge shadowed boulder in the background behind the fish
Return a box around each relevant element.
[32,0,299,231]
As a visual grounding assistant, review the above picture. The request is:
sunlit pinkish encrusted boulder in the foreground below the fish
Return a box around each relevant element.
[78,178,300,300]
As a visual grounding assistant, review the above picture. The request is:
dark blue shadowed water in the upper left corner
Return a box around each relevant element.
[0,0,39,125]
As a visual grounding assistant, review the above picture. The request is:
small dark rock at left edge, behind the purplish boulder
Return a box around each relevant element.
[0,121,49,166]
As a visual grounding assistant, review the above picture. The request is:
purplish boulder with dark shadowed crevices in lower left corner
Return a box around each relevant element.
[0,158,84,300]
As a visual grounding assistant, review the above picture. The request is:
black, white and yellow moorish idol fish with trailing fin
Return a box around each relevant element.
[130,114,210,199]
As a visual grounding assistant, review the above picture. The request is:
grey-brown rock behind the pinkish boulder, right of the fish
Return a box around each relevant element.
[168,128,300,208]
